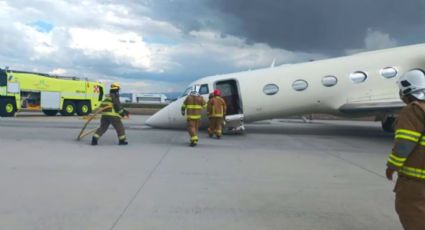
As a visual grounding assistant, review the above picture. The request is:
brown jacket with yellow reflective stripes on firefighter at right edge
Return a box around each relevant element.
[387,101,425,180]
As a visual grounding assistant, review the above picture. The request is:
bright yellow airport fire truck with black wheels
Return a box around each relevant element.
[0,68,104,117]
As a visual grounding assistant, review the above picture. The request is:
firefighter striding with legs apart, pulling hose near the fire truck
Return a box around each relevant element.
[91,82,129,145]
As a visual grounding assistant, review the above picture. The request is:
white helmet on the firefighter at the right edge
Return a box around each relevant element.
[397,69,425,100]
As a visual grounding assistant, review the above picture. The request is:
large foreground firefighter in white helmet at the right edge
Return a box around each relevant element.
[386,69,425,230]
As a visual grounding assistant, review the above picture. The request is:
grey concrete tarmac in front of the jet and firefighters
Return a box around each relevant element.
[0,114,401,230]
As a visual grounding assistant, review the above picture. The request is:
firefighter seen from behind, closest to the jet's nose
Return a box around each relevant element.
[181,91,206,147]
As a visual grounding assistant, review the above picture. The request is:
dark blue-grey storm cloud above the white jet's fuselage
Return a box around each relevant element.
[211,0,425,52]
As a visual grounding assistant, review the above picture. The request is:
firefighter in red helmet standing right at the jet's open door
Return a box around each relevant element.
[207,89,227,139]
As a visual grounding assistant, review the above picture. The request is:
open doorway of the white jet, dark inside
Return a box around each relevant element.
[215,79,245,133]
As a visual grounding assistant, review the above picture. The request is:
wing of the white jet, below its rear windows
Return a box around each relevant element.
[338,100,406,115]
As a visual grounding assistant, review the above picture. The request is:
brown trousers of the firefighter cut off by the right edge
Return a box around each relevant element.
[394,176,425,230]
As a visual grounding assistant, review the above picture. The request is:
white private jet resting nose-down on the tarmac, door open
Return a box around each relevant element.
[146,44,425,131]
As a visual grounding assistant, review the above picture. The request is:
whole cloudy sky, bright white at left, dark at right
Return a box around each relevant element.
[0,0,425,92]
